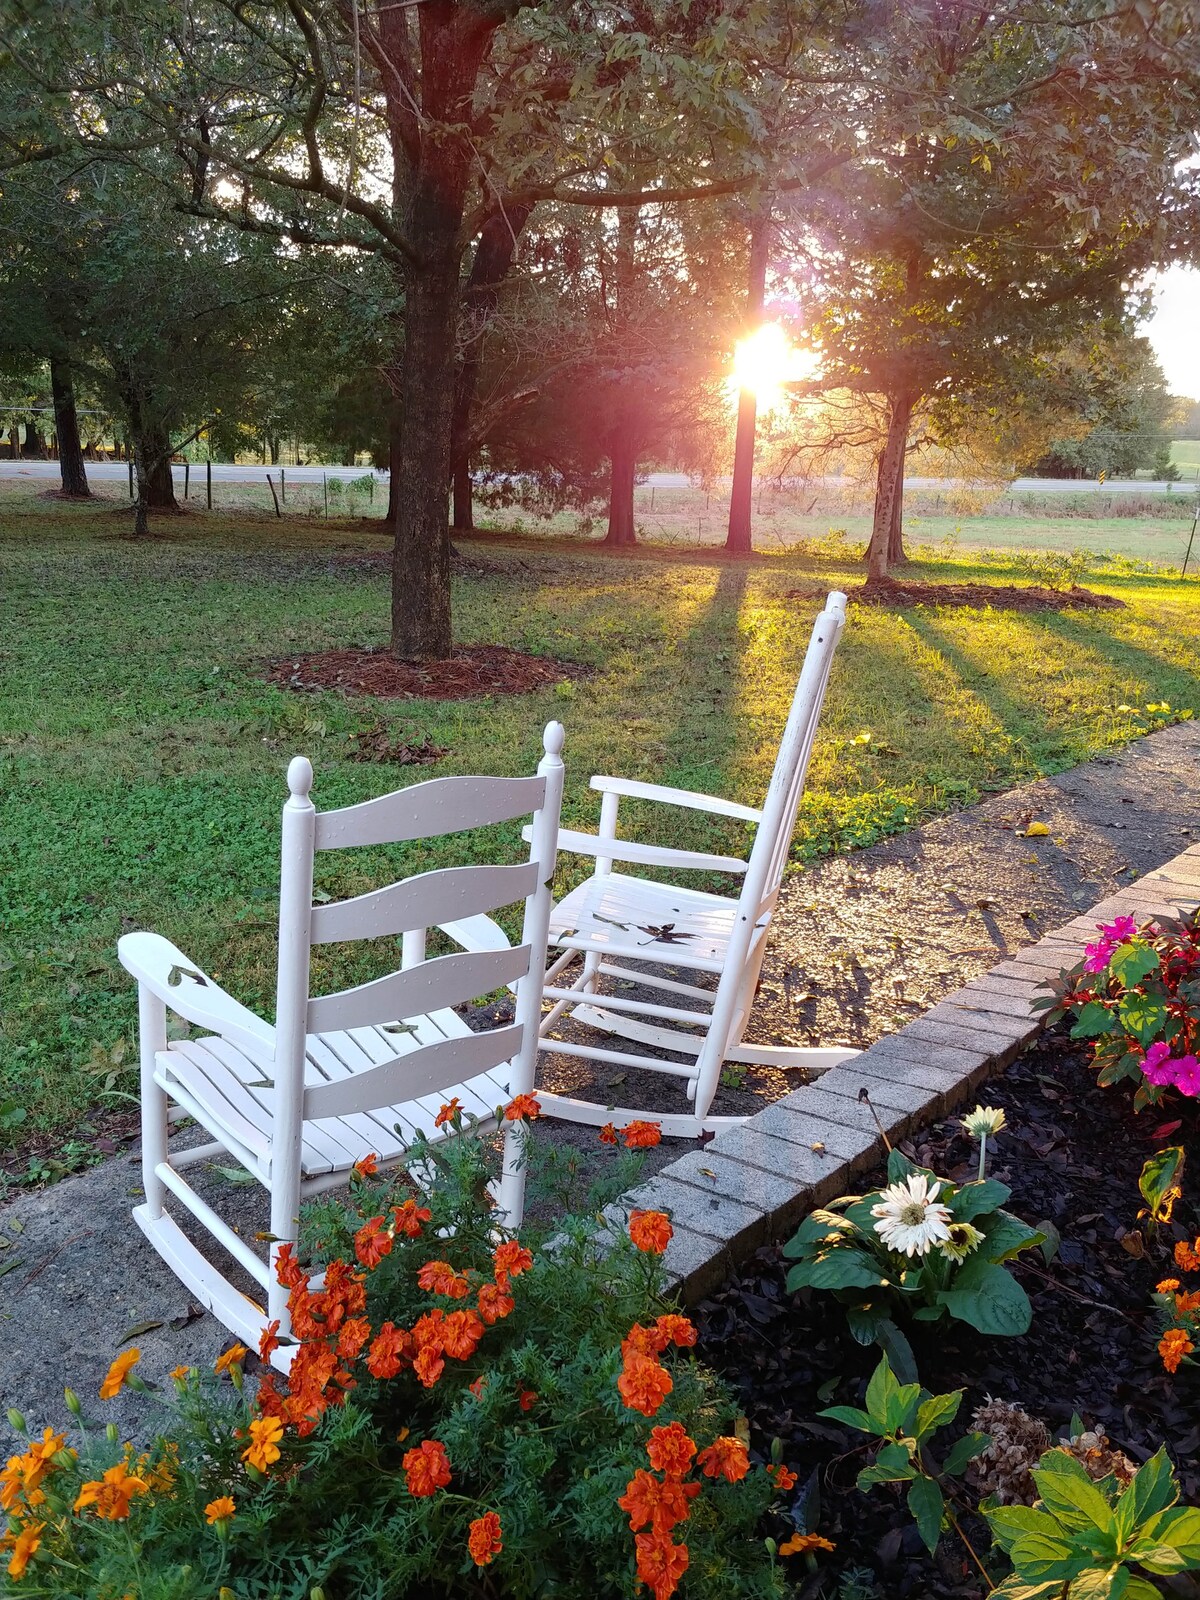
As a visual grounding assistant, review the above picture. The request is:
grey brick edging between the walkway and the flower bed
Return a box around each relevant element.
[605,845,1200,1302]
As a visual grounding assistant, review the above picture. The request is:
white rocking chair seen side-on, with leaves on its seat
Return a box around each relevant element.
[526,592,858,1138]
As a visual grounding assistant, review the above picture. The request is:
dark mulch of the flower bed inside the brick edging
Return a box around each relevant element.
[694,1032,1200,1600]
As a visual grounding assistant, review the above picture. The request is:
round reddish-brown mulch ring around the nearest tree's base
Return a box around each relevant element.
[266,645,587,699]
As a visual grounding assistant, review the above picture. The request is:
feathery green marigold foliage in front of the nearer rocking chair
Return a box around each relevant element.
[0,1138,786,1600]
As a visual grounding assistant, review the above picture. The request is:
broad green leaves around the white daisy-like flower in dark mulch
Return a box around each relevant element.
[784,1150,1045,1346]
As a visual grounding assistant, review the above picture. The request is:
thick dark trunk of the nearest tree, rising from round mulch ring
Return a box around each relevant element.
[390,259,459,661]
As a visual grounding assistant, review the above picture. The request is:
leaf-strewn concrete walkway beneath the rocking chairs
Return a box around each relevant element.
[0,723,1200,1434]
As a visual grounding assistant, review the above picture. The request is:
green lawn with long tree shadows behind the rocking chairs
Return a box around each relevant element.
[0,496,1200,1139]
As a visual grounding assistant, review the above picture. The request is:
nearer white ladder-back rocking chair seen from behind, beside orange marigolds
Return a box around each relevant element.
[118,722,563,1366]
